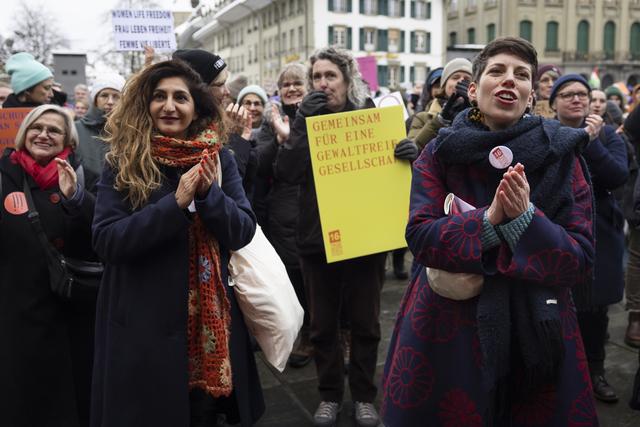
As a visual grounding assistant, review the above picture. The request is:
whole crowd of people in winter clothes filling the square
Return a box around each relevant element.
[0,37,640,427]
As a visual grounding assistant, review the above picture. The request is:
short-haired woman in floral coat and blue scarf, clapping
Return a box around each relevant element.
[382,37,597,427]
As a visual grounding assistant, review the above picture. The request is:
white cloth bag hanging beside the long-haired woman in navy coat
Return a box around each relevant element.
[229,225,304,372]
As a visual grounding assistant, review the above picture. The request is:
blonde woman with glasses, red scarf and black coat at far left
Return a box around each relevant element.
[0,105,94,427]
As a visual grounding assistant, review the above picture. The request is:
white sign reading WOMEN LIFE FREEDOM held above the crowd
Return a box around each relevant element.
[111,9,176,52]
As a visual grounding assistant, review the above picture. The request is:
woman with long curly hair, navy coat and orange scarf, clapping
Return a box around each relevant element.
[92,60,264,427]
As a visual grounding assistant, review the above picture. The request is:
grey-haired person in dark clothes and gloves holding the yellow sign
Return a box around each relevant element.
[275,47,417,426]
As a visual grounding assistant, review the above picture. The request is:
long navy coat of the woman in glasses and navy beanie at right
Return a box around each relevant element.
[578,125,629,309]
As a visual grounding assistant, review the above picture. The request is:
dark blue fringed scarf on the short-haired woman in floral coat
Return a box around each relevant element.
[434,108,589,423]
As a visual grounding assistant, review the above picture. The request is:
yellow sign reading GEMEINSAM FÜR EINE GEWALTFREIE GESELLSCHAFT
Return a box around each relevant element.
[306,106,411,262]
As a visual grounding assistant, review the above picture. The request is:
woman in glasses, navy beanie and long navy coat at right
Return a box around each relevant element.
[549,74,629,402]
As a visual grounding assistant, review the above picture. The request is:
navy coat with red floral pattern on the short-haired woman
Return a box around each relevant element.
[381,142,598,427]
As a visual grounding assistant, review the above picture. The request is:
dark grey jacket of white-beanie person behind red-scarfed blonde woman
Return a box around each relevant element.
[76,105,109,194]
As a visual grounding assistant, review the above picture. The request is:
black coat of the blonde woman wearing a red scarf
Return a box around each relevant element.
[0,150,95,427]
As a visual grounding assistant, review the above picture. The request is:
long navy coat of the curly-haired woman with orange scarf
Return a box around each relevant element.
[91,149,264,427]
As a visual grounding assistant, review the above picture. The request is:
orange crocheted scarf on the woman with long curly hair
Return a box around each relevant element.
[152,125,233,397]
